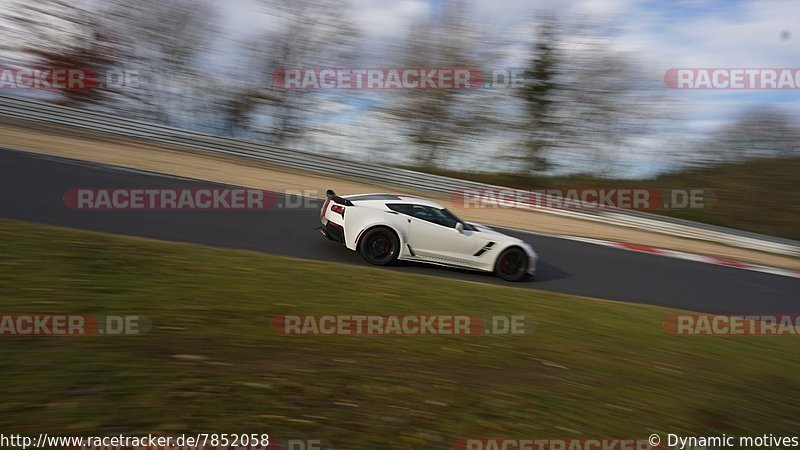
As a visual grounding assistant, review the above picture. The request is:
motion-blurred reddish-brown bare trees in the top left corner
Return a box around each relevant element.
[0,0,219,122]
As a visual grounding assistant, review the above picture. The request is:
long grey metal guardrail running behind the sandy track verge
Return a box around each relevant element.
[0,96,800,256]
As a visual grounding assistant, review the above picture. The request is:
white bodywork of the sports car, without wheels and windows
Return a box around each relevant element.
[320,194,538,275]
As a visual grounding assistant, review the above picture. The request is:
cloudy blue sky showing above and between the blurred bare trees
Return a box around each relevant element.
[9,0,800,177]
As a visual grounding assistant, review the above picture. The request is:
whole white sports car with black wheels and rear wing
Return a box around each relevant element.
[319,190,538,281]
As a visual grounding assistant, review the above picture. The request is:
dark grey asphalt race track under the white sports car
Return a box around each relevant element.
[0,149,800,314]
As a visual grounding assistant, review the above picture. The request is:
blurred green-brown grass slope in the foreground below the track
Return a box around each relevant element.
[0,221,800,449]
